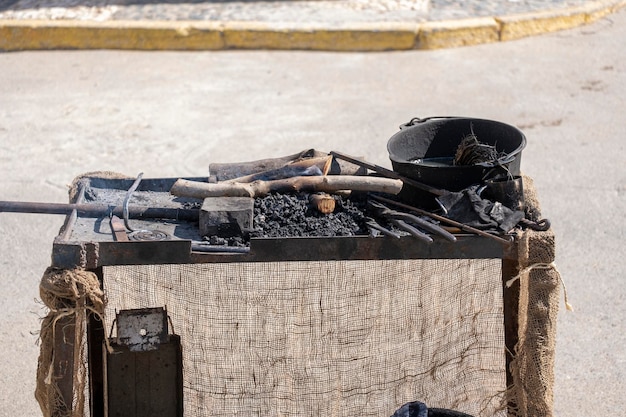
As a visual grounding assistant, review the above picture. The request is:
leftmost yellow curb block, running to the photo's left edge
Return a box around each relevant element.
[0,20,224,51]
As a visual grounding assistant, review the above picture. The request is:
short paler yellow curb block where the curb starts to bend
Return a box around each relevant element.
[416,17,500,49]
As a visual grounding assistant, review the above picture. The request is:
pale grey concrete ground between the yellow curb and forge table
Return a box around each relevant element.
[0,6,626,417]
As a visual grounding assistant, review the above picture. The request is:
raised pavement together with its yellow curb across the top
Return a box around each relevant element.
[0,0,626,51]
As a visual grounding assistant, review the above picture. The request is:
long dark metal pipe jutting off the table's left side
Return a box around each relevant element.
[0,201,200,221]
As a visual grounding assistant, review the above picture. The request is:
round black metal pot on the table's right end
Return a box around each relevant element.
[387,117,526,207]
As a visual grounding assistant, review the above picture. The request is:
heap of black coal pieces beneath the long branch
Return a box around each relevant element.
[250,193,368,238]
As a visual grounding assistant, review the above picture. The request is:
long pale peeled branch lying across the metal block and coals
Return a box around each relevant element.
[170,175,402,199]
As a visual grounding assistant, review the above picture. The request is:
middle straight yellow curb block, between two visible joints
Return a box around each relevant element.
[224,22,418,51]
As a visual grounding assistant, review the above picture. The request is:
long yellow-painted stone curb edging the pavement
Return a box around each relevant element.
[0,0,626,51]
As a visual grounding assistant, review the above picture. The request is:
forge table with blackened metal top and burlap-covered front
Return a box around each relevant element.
[46,176,558,417]
